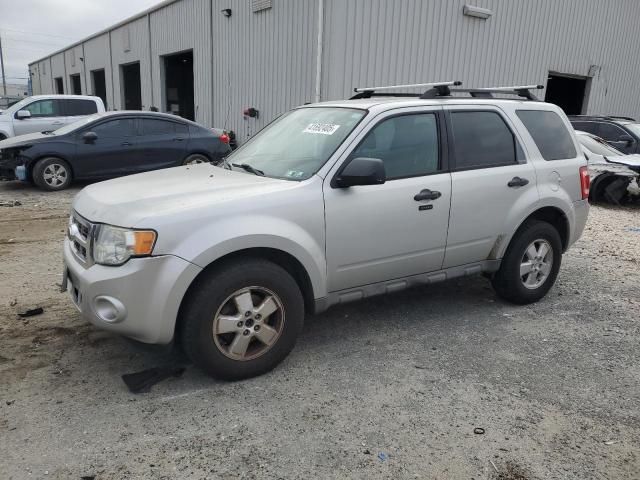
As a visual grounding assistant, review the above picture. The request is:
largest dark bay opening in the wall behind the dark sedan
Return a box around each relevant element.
[164,50,195,120]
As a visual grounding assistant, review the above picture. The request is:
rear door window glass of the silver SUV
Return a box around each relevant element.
[451,111,521,170]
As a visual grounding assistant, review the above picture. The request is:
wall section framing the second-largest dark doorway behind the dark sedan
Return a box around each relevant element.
[111,17,153,110]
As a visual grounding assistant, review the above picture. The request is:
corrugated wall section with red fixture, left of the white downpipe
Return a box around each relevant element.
[212,0,318,140]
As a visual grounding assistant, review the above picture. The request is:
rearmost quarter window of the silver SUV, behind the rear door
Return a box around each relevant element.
[516,110,576,160]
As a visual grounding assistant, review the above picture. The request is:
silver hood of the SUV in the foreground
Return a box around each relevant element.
[73,164,298,228]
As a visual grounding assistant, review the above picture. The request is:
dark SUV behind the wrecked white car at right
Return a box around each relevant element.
[569,115,640,154]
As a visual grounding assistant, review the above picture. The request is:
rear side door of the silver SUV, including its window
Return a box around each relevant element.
[444,105,538,268]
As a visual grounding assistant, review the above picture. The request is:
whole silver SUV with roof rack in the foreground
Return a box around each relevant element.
[64,83,589,379]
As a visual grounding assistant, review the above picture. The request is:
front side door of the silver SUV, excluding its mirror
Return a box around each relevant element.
[324,107,451,292]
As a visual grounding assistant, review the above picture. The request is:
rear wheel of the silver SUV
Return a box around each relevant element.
[491,220,562,305]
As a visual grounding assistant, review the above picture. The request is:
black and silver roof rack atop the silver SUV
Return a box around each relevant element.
[350,81,544,102]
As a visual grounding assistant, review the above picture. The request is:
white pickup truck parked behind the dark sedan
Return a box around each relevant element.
[0,95,105,140]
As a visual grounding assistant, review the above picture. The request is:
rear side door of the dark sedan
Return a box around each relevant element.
[138,117,189,170]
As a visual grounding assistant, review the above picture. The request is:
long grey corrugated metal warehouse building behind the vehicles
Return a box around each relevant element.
[29,0,640,141]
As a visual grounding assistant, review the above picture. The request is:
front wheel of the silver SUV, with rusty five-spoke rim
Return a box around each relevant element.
[180,259,304,380]
